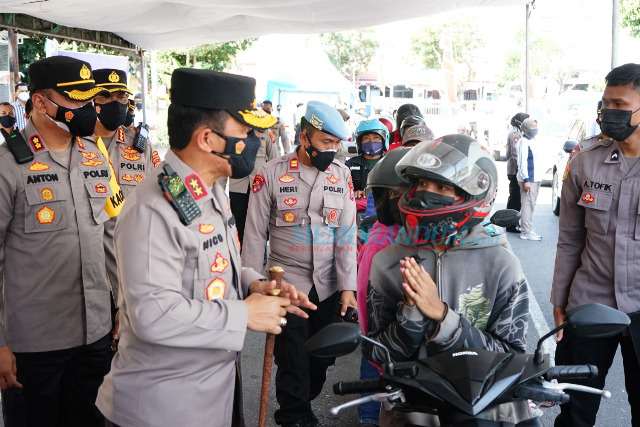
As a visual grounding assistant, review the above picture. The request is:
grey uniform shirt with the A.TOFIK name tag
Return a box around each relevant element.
[551,139,640,313]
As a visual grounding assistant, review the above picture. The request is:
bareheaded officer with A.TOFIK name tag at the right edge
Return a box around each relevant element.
[551,64,640,427]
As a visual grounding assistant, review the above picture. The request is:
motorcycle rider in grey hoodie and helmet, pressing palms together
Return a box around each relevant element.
[363,134,538,426]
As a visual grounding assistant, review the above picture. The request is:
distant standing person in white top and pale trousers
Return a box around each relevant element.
[517,118,545,241]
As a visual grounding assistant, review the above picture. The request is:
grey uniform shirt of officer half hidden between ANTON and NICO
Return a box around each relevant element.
[102,126,160,303]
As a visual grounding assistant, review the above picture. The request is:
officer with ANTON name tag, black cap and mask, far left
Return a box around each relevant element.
[0,56,123,427]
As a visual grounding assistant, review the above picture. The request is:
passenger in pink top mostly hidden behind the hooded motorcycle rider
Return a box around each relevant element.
[357,147,409,427]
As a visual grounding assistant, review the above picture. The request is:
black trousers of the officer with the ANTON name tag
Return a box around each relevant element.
[2,334,113,427]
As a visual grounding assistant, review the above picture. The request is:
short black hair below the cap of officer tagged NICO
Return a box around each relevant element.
[167,104,230,150]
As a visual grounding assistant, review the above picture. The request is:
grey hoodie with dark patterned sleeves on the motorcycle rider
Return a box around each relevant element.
[363,225,530,422]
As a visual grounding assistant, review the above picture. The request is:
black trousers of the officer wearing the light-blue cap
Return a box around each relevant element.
[274,288,341,424]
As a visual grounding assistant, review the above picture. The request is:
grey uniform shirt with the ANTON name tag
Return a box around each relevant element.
[0,121,117,352]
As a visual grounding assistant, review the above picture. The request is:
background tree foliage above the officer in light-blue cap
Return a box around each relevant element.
[321,31,378,80]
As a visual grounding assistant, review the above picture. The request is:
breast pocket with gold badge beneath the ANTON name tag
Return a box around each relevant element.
[24,185,67,233]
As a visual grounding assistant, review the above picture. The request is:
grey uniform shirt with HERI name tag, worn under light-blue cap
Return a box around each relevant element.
[242,153,356,301]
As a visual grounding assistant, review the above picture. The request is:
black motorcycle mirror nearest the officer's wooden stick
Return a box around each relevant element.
[304,322,360,358]
